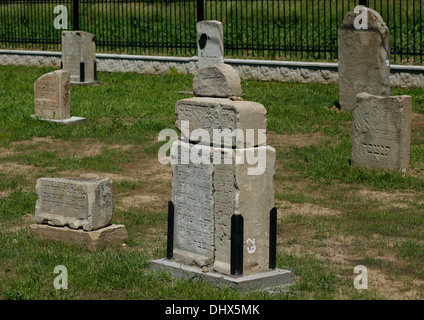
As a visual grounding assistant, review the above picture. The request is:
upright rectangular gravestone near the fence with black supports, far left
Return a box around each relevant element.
[62,31,97,85]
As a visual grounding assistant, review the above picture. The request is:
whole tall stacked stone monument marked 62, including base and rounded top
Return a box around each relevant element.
[152,58,293,290]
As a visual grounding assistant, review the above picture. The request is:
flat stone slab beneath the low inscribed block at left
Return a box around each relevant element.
[28,224,128,251]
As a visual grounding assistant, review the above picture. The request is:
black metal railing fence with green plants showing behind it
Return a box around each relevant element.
[0,0,424,64]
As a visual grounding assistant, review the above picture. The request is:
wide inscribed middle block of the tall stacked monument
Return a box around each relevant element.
[175,97,267,147]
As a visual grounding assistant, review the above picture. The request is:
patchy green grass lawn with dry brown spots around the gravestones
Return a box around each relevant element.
[0,67,424,300]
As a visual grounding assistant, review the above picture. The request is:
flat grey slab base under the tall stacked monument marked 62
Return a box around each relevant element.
[151,259,293,291]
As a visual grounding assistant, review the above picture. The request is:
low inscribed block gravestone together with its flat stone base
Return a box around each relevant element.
[28,178,127,250]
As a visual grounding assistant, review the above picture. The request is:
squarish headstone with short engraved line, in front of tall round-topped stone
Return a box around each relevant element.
[351,93,412,171]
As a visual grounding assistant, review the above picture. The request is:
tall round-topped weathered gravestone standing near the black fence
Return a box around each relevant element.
[338,8,390,111]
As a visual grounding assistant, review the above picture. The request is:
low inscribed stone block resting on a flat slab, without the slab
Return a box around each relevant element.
[35,178,113,231]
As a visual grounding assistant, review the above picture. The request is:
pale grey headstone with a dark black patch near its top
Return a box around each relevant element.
[197,20,224,69]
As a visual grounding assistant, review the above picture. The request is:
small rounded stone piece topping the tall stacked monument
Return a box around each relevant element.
[193,63,242,98]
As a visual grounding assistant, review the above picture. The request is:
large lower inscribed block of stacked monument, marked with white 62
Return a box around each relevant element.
[171,141,275,275]
